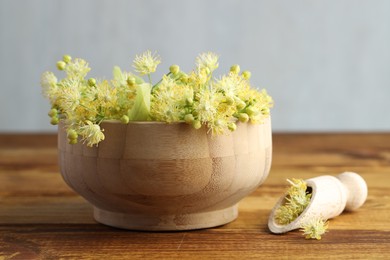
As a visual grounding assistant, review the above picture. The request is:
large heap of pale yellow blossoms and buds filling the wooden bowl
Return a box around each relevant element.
[41,51,273,146]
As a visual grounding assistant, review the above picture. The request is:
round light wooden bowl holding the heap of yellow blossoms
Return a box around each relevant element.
[58,119,272,230]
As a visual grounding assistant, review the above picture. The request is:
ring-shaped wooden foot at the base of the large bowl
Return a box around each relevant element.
[93,204,238,231]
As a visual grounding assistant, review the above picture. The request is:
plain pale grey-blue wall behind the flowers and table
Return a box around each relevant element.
[0,0,390,132]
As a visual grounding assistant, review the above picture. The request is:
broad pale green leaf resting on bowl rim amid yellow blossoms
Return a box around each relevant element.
[128,83,152,121]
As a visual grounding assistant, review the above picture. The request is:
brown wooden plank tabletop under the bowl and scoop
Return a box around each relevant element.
[0,133,390,259]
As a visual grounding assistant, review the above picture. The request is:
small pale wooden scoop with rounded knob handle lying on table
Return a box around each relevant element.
[268,172,367,234]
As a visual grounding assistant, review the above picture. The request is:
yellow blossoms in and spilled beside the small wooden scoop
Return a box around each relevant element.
[275,179,328,240]
